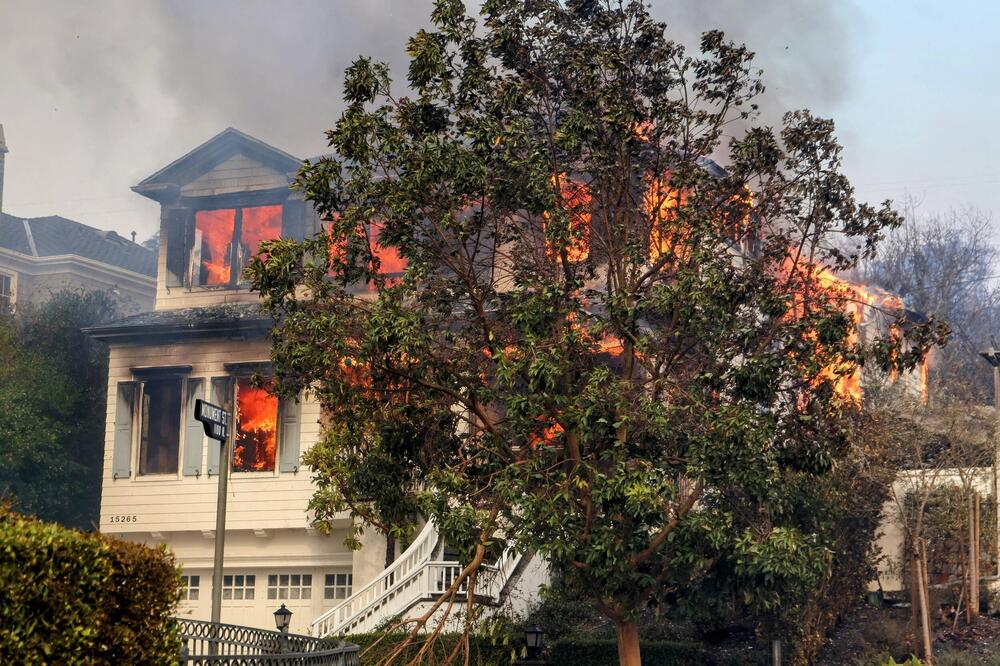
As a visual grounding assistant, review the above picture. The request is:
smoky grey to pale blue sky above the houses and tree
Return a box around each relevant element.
[0,0,1000,241]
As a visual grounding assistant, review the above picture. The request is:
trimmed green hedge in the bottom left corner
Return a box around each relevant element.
[0,505,179,664]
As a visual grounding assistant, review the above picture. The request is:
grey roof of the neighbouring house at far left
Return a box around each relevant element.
[0,213,156,277]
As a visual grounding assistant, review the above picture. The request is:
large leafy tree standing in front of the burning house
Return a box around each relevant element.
[248,0,943,665]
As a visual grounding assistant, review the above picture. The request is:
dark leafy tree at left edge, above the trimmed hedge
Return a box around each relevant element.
[0,291,115,528]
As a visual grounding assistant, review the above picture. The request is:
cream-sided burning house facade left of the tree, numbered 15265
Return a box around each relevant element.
[90,128,538,633]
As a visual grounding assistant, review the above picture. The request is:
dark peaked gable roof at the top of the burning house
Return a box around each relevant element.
[132,127,302,201]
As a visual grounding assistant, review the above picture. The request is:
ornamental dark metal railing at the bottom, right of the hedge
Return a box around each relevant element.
[177,618,361,666]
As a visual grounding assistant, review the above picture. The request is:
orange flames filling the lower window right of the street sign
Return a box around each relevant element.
[233,377,278,472]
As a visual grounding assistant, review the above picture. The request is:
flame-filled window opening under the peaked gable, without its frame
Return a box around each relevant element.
[188,205,283,287]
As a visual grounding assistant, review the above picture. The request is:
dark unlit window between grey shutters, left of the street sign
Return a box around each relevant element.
[139,378,181,474]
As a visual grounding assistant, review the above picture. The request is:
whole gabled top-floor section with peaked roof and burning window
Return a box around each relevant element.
[132,127,314,310]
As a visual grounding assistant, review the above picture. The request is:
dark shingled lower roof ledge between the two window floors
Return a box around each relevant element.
[84,303,272,343]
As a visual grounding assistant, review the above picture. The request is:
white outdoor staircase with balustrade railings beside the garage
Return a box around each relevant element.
[312,521,521,638]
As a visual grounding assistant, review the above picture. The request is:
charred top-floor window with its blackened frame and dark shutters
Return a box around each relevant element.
[163,195,309,289]
